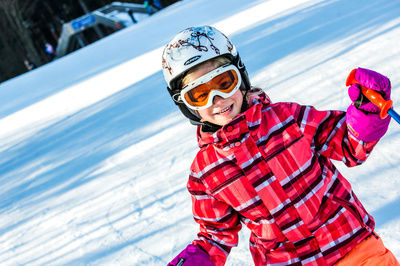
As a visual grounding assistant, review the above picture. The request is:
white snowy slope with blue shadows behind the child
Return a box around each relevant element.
[0,0,400,265]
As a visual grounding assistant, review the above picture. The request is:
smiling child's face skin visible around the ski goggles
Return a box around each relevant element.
[185,62,243,126]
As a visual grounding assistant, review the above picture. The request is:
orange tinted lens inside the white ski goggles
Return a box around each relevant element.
[184,69,239,107]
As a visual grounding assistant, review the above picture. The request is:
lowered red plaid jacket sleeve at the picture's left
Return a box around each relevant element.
[187,171,242,266]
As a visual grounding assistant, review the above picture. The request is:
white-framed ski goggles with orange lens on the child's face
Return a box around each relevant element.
[179,65,242,110]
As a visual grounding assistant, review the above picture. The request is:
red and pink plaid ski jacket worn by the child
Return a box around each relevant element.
[187,92,376,265]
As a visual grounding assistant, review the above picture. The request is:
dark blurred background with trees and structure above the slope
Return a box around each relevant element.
[0,0,177,83]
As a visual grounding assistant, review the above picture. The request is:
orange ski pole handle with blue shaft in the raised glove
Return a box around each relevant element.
[346,69,400,124]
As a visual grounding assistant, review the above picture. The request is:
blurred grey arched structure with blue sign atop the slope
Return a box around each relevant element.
[56,2,157,58]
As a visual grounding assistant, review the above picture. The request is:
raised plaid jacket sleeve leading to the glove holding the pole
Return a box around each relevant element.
[292,104,378,166]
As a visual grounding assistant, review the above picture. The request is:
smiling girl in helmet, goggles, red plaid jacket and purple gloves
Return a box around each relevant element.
[162,26,399,266]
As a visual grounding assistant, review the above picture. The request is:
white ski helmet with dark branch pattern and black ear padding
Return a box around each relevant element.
[162,26,250,125]
